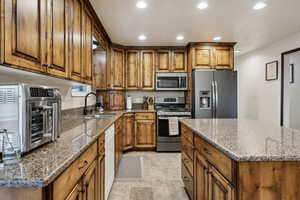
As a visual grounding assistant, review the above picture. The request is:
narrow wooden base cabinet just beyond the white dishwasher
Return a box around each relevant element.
[115,118,123,172]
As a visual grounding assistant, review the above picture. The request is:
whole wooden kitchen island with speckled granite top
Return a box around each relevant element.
[180,119,300,200]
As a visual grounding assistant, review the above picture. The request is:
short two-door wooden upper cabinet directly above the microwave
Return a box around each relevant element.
[156,50,187,72]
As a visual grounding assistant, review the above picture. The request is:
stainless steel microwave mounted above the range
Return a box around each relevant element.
[156,73,188,90]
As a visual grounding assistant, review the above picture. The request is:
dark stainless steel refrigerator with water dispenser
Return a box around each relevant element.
[192,70,237,118]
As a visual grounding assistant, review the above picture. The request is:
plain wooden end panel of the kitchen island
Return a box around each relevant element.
[238,161,300,200]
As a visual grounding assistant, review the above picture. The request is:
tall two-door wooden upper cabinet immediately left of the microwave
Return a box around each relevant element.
[125,50,155,90]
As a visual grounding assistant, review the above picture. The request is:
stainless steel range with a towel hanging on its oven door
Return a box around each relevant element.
[155,97,191,152]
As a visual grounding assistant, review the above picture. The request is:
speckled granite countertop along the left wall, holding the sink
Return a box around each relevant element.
[0,112,124,187]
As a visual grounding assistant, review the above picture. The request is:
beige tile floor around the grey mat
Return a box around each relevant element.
[109,152,188,200]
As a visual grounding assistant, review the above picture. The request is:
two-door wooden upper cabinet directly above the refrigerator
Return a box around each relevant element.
[190,43,234,70]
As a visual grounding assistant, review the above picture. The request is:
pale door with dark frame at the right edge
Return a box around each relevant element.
[282,49,300,130]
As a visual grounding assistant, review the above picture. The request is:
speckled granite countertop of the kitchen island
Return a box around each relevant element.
[180,119,300,162]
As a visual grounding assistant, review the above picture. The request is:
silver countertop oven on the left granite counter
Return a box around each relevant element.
[0,84,61,154]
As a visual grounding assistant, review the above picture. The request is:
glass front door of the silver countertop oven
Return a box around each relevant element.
[26,101,57,151]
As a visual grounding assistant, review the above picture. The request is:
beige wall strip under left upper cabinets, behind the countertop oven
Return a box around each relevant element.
[0,66,96,110]
